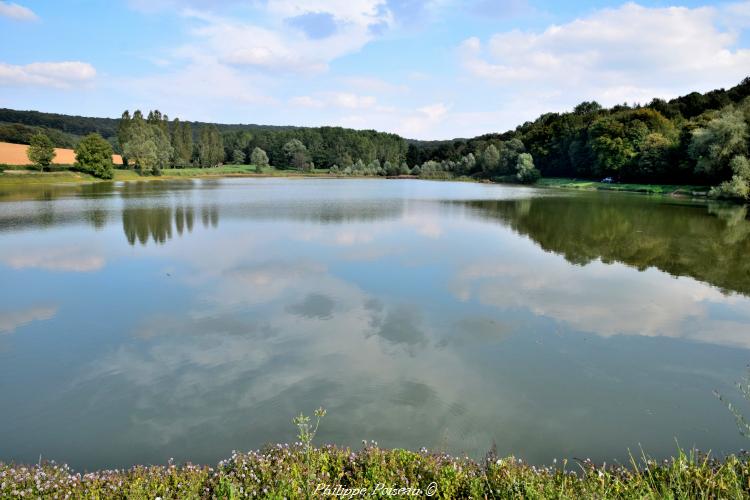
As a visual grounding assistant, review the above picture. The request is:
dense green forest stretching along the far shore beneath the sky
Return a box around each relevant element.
[0,78,750,199]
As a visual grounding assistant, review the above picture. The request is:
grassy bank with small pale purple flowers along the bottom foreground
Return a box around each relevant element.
[0,445,750,499]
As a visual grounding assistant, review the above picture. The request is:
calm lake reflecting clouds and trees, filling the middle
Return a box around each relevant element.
[0,179,750,469]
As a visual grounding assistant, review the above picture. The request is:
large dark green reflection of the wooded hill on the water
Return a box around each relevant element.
[458,196,750,295]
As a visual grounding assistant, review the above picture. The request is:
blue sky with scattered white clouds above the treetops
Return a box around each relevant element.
[0,0,750,139]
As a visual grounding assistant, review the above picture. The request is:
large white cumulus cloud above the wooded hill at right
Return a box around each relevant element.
[460,3,750,104]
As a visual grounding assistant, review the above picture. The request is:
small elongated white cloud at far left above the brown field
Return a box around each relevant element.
[0,61,96,88]
